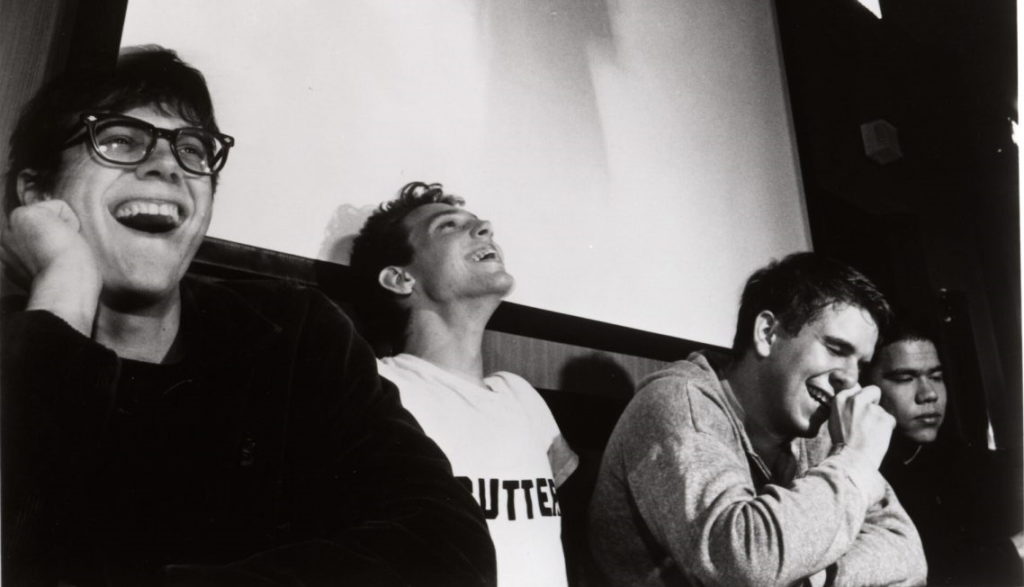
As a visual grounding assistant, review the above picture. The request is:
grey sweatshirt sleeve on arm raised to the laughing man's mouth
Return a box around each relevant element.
[621,376,915,585]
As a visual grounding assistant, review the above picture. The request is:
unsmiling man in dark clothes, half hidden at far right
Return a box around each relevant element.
[865,319,1024,585]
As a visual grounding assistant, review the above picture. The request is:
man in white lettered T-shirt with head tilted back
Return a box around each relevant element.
[352,182,578,587]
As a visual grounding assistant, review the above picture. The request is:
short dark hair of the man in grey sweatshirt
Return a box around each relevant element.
[732,252,892,357]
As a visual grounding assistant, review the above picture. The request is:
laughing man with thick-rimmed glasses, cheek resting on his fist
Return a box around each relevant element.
[0,47,495,586]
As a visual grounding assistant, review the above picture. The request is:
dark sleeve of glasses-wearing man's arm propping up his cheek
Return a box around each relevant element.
[0,310,120,585]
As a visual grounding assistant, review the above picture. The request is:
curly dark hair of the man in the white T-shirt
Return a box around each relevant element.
[349,181,465,352]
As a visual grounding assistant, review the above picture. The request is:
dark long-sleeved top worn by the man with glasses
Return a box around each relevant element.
[0,279,495,586]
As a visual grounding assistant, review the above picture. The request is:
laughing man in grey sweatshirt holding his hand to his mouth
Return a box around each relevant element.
[591,253,926,585]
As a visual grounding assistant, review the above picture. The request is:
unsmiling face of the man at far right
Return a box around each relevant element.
[871,340,946,444]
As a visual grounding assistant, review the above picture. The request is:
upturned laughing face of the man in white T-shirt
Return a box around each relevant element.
[403,203,514,303]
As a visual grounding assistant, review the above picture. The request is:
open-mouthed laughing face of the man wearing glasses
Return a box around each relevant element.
[48,108,213,306]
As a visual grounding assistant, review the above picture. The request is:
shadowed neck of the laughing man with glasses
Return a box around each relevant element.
[93,290,181,363]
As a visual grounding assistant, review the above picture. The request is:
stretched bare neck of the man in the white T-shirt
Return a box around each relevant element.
[403,298,501,385]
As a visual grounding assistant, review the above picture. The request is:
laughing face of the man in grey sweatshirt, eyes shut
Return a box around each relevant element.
[759,304,879,438]
